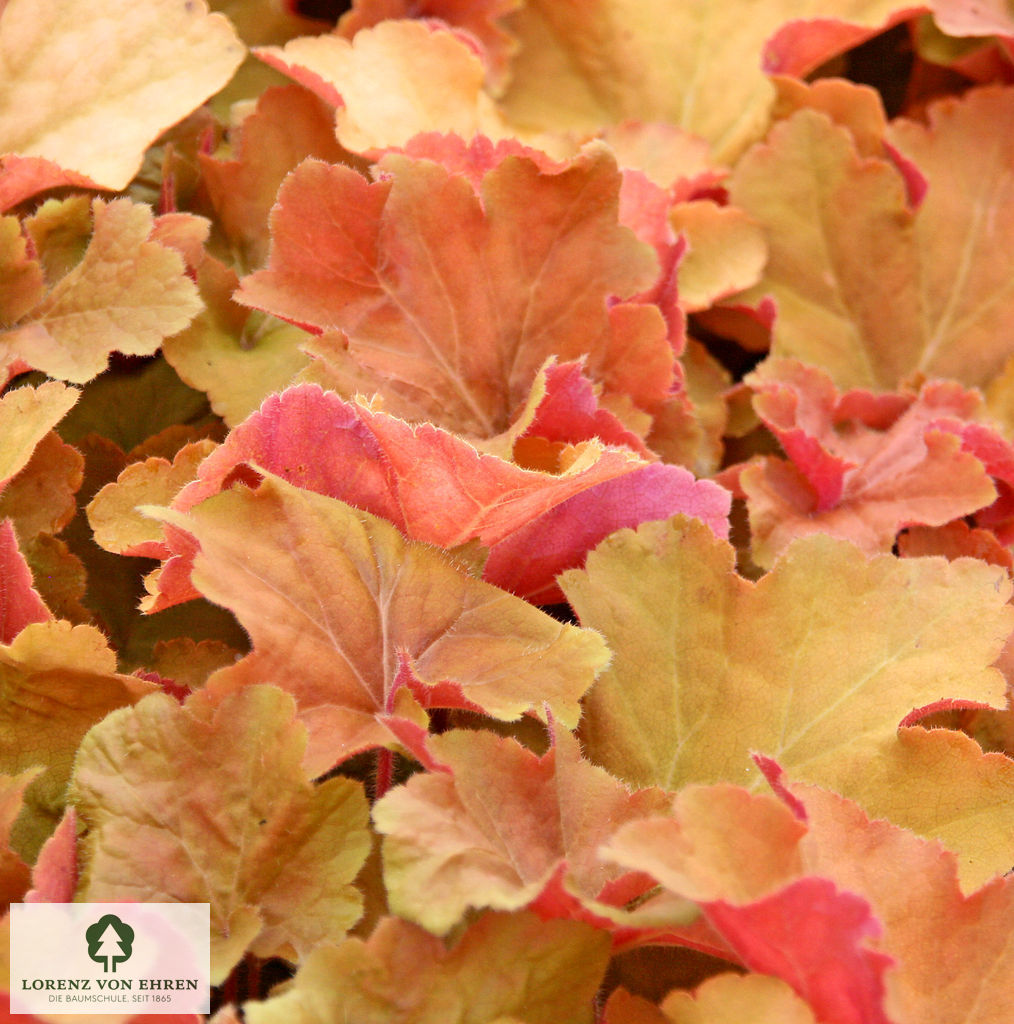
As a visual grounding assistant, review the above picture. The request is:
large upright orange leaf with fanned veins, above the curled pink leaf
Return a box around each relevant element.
[237,147,673,437]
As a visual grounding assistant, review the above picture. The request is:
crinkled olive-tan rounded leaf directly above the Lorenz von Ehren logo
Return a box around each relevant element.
[72,686,370,982]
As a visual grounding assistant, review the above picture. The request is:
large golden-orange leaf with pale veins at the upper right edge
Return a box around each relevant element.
[729,88,1014,390]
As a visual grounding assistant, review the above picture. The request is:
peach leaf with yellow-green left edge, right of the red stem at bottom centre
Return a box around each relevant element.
[373,730,682,934]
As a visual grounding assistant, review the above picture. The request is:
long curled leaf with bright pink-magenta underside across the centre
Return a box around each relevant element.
[143,386,729,610]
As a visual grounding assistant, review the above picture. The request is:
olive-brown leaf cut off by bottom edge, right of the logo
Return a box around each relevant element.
[244,913,608,1024]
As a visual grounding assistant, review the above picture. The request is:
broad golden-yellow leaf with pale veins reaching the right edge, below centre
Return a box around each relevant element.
[561,517,1012,794]
